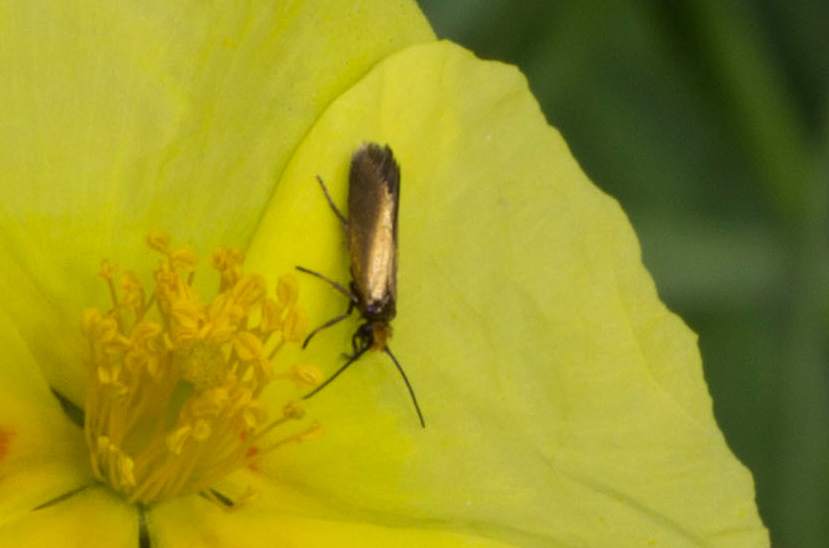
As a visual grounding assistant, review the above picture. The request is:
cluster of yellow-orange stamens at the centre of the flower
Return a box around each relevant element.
[83,232,321,504]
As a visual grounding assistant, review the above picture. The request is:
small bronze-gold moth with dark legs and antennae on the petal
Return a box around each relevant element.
[296,143,426,428]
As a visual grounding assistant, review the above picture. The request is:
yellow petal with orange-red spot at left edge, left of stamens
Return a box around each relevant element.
[0,308,93,528]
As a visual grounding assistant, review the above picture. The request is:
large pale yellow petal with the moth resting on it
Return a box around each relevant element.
[248,43,768,547]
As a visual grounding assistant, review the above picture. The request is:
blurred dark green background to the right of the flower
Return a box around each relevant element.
[419,0,829,548]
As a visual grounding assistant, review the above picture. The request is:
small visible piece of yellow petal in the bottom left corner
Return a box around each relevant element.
[0,486,138,548]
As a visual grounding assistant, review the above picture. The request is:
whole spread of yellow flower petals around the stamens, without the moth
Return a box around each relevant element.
[0,0,768,548]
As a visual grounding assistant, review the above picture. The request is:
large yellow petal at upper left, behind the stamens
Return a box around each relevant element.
[0,0,433,402]
